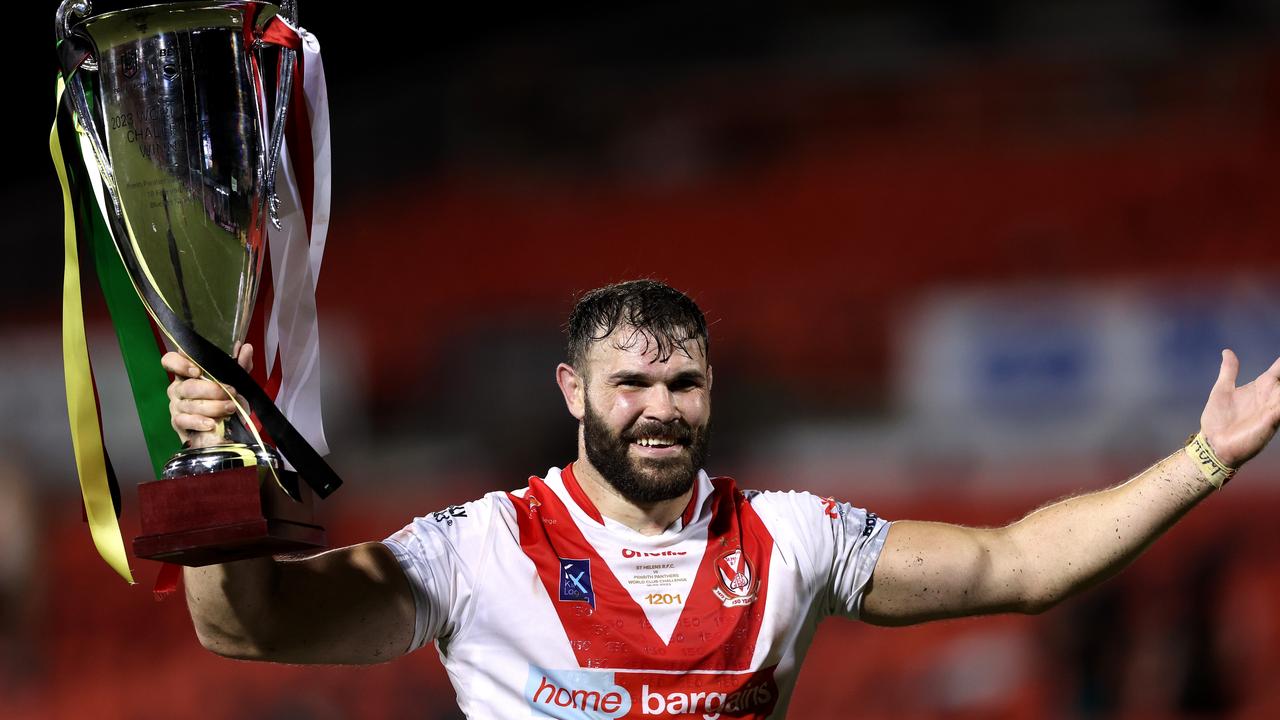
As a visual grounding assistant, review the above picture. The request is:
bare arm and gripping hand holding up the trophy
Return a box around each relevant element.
[161,346,415,664]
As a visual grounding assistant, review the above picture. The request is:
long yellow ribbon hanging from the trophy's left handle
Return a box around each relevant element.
[49,77,133,584]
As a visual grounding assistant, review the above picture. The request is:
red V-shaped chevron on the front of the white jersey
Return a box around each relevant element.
[508,468,773,671]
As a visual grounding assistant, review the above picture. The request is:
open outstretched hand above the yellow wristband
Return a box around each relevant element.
[1201,350,1280,468]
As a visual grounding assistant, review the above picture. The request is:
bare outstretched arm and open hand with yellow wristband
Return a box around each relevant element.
[861,350,1280,625]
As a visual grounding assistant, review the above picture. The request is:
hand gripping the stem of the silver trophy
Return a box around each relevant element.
[160,343,253,447]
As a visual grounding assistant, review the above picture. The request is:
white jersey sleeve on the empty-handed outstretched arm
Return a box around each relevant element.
[751,492,890,619]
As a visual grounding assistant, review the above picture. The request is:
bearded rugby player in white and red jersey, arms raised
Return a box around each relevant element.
[164,281,1280,719]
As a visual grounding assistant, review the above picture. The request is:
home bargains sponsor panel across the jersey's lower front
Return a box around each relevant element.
[525,665,778,720]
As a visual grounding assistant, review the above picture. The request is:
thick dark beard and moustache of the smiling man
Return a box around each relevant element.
[582,400,710,505]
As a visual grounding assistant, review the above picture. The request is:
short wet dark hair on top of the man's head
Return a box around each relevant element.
[568,279,708,372]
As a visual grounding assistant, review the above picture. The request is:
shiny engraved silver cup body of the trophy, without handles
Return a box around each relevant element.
[100,31,264,352]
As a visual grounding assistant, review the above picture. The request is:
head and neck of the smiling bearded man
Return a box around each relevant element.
[556,281,712,533]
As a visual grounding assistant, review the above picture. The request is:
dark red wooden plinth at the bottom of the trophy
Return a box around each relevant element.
[133,458,328,568]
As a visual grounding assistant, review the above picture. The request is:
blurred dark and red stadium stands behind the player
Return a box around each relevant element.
[0,0,1280,720]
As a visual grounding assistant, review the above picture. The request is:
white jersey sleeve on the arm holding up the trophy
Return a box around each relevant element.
[383,497,495,652]
